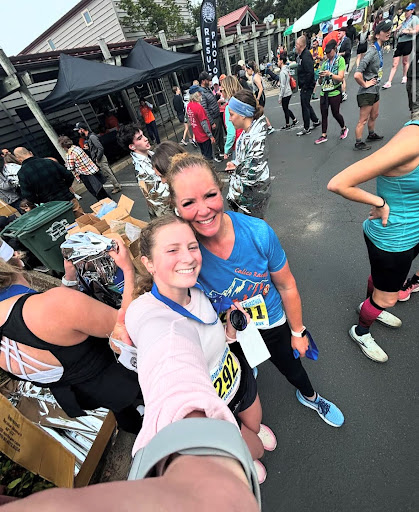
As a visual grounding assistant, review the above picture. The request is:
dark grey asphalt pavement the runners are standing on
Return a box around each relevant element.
[83,55,419,512]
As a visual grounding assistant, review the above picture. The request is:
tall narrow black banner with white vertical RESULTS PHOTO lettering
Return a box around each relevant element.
[201,0,219,76]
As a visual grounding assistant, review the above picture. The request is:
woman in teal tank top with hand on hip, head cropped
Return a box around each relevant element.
[327,120,419,363]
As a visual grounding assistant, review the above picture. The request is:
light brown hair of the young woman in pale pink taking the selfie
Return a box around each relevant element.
[133,214,189,297]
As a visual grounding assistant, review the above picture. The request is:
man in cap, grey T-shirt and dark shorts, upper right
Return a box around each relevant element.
[354,20,391,151]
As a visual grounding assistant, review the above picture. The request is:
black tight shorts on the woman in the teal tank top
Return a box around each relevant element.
[364,233,419,292]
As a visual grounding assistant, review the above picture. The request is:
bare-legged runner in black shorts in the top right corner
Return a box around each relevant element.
[383,3,419,89]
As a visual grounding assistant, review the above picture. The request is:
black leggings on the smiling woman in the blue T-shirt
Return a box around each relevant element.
[259,322,314,397]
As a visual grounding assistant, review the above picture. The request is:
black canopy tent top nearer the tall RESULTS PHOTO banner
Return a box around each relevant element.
[124,39,202,78]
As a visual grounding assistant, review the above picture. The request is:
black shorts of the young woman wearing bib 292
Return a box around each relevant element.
[228,348,258,427]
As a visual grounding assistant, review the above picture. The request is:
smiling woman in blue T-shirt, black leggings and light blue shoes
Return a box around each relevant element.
[167,155,344,427]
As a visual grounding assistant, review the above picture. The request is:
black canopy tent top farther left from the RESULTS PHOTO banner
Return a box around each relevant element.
[39,53,151,112]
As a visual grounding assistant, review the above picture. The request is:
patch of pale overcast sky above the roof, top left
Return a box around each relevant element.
[0,0,79,56]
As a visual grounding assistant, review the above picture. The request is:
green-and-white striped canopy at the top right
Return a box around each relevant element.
[284,0,371,36]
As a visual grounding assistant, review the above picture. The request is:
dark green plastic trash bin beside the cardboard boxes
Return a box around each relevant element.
[0,201,74,272]
